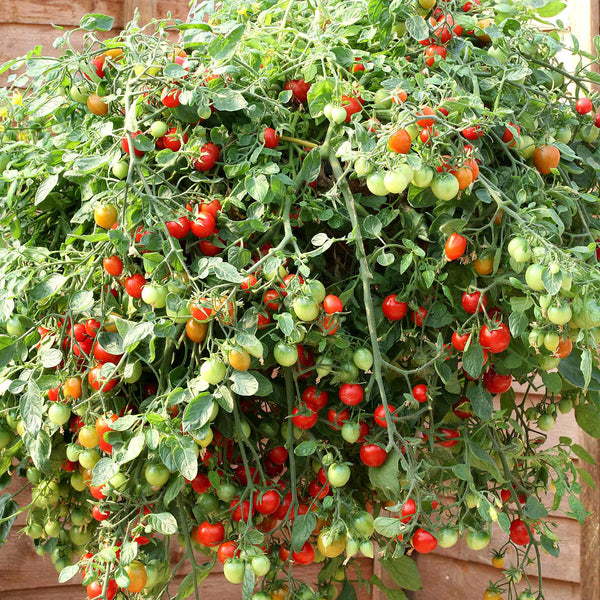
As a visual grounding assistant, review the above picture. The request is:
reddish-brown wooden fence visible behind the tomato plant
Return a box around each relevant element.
[0,0,600,600]
